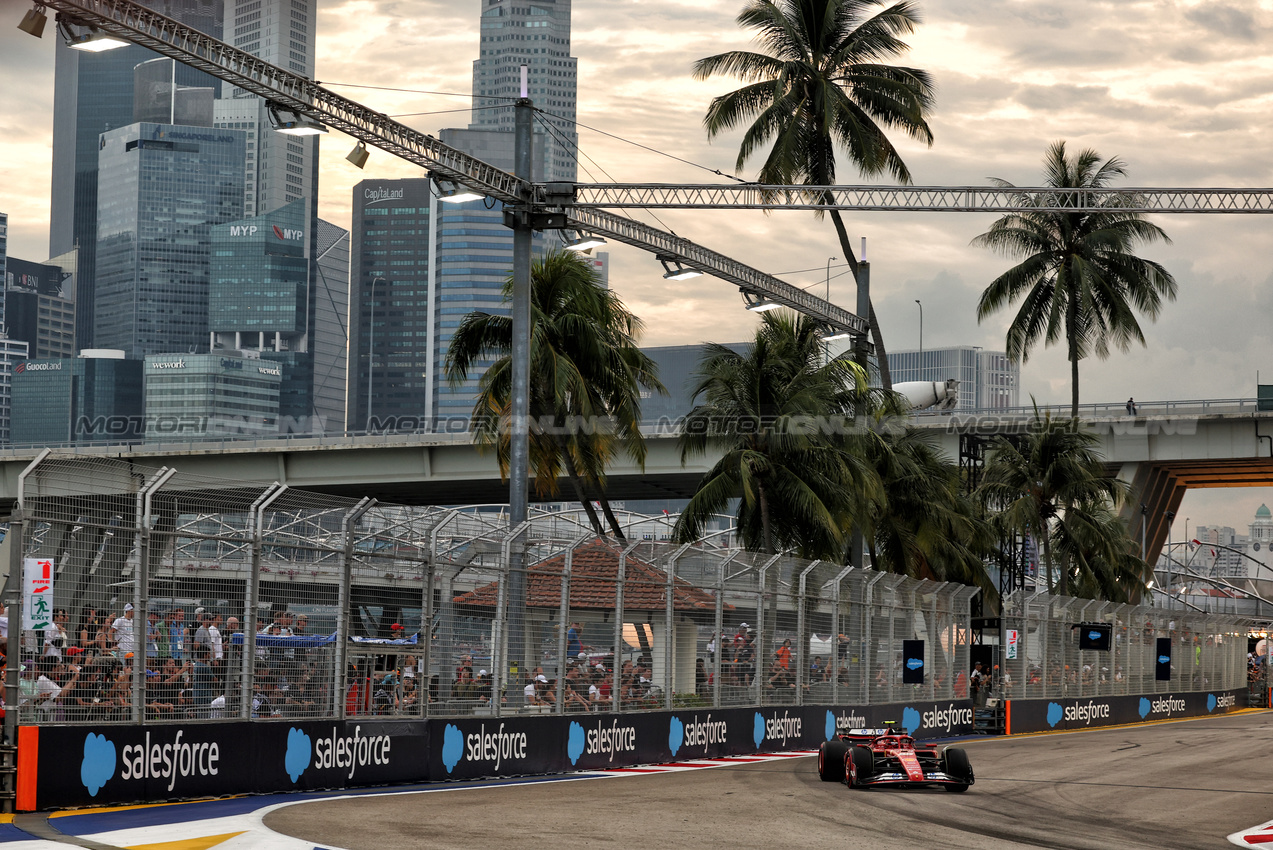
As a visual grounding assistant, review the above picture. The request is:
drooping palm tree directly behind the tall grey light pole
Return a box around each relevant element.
[447,251,667,538]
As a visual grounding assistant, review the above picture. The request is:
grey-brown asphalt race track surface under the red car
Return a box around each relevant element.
[265,711,1273,850]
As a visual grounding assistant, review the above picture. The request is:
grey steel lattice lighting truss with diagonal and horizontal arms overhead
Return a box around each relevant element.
[41,0,1273,335]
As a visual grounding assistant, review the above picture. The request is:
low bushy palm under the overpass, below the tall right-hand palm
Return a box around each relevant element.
[978,410,1143,596]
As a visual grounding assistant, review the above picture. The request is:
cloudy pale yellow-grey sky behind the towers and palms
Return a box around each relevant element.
[0,0,1273,531]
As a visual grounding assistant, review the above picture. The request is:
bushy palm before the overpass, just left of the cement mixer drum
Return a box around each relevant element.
[672,310,877,561]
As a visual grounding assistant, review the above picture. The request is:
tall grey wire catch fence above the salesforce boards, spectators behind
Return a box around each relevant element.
[5,456,1245,724]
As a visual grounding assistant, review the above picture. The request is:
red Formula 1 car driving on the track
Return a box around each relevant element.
[817,729,973,791]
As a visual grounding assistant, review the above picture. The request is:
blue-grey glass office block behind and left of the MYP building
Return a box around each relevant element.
[93,123,246,359]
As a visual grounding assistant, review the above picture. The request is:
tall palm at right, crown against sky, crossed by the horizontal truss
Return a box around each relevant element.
[973,141,1176,416]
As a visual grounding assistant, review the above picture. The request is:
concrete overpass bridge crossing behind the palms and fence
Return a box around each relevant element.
[0,398,1273,561]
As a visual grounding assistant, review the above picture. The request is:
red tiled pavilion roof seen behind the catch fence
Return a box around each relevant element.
[454,540,733,611]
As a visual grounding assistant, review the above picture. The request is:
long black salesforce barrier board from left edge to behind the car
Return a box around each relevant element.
[27,701,973,811]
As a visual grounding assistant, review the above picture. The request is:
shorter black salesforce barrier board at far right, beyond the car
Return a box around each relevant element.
[1008,688,1246,734]
